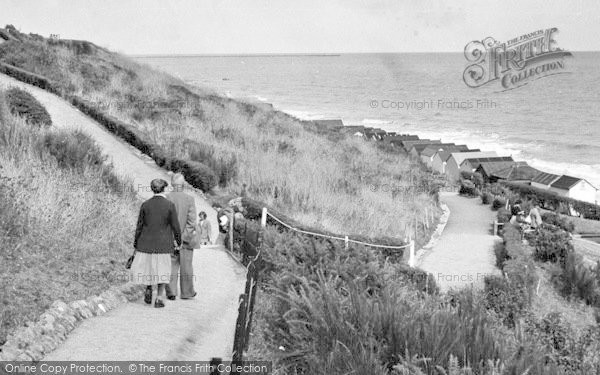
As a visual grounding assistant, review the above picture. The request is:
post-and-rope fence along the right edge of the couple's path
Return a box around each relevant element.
[228,207,415,366]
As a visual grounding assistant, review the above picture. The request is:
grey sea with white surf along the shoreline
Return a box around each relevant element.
[135,52,600,197]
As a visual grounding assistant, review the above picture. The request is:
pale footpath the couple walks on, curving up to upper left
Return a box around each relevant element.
[0,74,245,361]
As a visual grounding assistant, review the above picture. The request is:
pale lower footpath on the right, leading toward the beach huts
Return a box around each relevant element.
[418,193,500,291]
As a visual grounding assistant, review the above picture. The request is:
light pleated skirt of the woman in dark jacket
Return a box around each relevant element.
[131,251,171,285]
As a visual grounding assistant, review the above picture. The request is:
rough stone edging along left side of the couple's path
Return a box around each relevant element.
[0,282,144,362]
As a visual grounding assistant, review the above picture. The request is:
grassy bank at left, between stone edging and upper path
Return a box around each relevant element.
[0,91,138,344]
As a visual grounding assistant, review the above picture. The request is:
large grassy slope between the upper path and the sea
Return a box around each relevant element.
[0,27,437,242]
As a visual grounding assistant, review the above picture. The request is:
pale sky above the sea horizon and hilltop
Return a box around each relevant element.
[0,0,600,55]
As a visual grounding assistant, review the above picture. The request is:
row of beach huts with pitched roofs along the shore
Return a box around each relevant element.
[315,120,598,204]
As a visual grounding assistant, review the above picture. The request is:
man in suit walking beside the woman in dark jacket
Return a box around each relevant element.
[167,173,196,300]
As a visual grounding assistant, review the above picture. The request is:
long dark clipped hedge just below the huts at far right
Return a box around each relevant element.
[501,181,600,220]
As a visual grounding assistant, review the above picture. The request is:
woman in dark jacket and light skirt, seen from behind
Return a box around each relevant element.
[131,179,181,307]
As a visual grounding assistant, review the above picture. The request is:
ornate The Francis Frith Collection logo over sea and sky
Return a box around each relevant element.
[463,27,572,91]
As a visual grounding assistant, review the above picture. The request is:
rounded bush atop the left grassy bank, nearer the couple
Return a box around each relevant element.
[40,131,105,171]
